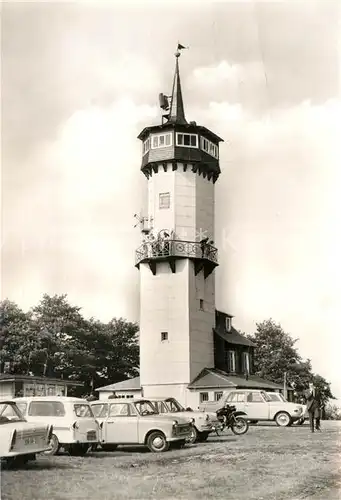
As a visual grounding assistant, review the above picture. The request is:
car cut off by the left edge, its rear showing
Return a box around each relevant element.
[0,400,53,466]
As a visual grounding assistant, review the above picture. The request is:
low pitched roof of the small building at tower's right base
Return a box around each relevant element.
[188,368,283,390]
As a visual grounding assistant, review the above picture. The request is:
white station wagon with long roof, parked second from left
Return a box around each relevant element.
[14,396,99,456]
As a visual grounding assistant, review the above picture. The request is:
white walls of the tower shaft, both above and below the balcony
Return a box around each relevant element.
[140,164,215,398]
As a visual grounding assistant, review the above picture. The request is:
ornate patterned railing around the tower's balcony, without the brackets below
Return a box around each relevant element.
[135,240,218,265]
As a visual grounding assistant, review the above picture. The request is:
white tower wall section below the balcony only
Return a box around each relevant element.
[140,259,215,388]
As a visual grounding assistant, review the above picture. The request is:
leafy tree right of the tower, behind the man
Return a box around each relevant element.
[247,319,334,404]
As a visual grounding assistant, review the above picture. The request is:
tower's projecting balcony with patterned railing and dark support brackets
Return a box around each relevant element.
[135,239,218,278]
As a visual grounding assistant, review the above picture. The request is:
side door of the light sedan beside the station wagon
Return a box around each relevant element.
[104,403,138,444]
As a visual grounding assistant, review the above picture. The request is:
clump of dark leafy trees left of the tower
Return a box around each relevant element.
[0,294,139,395]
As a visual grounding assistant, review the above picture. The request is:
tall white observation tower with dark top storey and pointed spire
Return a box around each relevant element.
[136,47,222,405]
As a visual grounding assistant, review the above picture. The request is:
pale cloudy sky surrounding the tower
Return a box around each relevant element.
[1,0,341,398]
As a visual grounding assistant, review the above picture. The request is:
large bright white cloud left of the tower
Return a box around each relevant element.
[2,99,156,319]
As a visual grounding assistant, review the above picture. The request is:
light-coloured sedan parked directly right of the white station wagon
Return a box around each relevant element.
[90,398,192,452]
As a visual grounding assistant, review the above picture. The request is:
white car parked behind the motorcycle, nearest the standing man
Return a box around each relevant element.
[199,389,303,427]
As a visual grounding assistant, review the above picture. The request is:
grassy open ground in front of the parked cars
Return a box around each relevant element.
[1,422,341,500]
